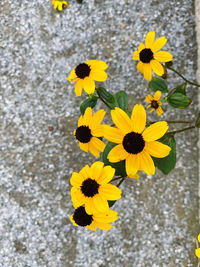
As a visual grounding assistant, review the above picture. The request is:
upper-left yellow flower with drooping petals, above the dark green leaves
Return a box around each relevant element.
[67,60,108,96]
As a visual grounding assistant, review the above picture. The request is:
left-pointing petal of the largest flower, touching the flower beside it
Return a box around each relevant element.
[103,125,124,144]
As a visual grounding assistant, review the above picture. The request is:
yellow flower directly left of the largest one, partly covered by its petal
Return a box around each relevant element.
[74,107,106,157]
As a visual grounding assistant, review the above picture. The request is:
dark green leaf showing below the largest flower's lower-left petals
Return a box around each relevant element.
[102,142,127,177]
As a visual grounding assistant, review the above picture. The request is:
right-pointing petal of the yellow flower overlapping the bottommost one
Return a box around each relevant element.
[99,184,122,200]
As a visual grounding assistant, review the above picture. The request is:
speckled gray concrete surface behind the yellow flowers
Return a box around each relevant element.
[0,0,199,267]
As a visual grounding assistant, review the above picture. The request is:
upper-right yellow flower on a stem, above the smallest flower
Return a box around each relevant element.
[133,32,173,81]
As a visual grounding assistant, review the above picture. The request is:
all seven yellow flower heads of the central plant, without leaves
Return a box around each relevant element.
[68,32,172,231]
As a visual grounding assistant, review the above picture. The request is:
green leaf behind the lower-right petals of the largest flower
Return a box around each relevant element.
[152,134,176,174]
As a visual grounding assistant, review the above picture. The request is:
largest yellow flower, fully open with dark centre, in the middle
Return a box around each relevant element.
[104,104,171,178]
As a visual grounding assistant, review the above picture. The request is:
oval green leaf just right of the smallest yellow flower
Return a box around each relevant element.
[167,93,191,109]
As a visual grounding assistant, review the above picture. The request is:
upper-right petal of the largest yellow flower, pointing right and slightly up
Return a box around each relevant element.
[142,121,169,142]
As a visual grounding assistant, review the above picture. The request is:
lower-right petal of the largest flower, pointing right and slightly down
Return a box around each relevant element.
[144,141,171,158]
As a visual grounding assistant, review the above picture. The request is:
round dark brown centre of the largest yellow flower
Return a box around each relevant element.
[122,132,145,154]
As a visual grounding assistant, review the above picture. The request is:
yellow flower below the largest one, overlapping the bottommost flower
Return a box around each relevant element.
[70,161,122,215]
